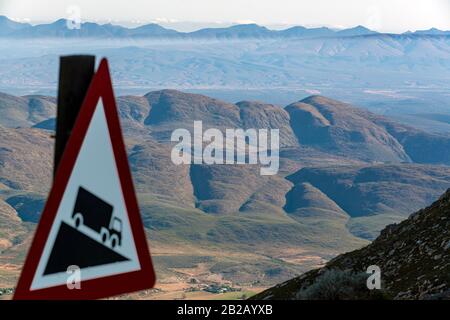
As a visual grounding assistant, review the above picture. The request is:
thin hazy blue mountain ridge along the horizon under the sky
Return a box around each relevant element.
[0,16,450,39]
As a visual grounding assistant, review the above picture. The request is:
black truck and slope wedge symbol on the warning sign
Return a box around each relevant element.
[44,187,129,275]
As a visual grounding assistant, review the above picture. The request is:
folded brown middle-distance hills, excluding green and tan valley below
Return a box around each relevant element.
[0,90,450,240]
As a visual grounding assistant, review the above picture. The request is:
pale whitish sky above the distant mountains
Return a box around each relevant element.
[0,0,450,32]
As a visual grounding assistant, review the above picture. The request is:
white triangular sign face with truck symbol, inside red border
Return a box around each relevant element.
[31,99,141,290]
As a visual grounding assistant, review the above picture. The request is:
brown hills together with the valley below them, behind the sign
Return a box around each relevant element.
[0,90,450,294]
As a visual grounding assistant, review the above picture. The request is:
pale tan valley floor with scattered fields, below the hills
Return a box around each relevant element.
[0,239,326,300]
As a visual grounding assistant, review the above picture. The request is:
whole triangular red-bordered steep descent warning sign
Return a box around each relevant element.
[14,59,155,299]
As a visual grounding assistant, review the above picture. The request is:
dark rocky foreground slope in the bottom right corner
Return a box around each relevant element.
[254,189,450,299]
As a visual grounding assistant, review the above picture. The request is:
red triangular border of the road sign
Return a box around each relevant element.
[13,59,156,300]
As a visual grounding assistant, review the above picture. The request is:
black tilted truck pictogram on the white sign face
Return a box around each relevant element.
[72,187,122,248]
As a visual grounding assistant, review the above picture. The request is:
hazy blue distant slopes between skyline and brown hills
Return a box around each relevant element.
[0,25,450,120]
